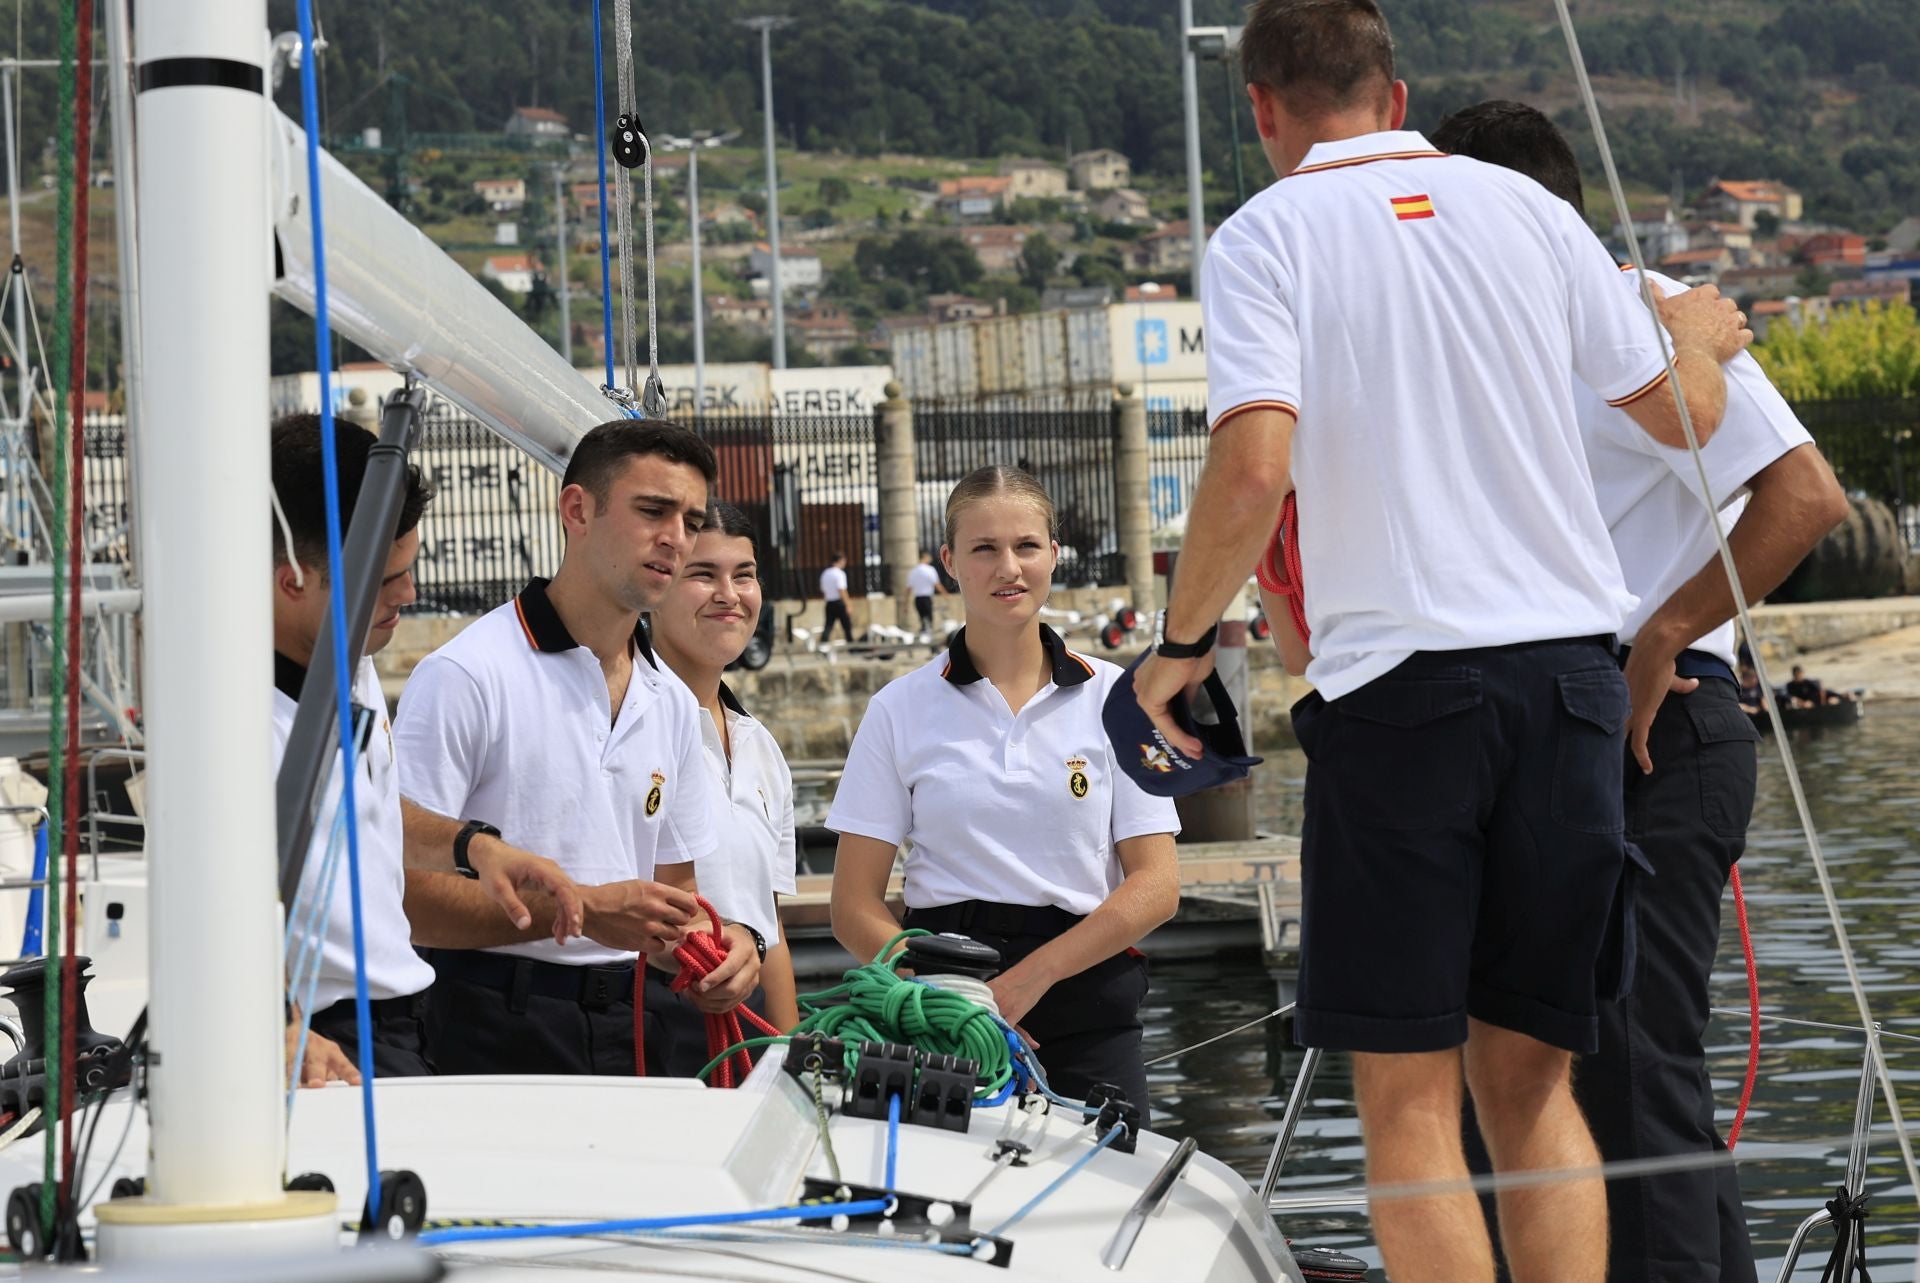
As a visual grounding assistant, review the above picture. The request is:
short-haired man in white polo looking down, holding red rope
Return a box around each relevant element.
[396,419,764,1076]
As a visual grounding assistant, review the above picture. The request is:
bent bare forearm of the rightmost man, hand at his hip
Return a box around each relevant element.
[1636,444,1847,653]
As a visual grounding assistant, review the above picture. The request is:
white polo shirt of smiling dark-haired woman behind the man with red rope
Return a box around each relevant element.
[693,682,799,949]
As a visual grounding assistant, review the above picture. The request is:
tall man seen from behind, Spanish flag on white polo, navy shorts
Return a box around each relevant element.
[1135,0,1749,1283]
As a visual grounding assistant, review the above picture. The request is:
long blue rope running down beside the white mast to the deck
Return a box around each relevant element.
[298,0,380,1214]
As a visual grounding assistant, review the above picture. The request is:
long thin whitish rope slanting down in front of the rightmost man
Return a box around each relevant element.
[1553,0,1920,1283]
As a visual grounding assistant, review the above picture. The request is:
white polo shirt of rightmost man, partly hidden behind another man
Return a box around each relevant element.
[1576,271,1812,666]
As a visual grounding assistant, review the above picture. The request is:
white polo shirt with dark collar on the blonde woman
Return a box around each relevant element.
[828,624,1181,914]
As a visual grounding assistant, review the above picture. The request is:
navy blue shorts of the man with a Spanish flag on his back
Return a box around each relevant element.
[1292,640,1630,1053]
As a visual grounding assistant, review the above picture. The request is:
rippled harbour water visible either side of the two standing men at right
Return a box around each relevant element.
[1146,703,1920,1283]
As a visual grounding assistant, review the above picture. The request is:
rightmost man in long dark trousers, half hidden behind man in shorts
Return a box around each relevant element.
[1432,102,1847,1283]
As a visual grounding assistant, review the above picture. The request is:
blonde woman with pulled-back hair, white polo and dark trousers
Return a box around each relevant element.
[828,465,1179,1118]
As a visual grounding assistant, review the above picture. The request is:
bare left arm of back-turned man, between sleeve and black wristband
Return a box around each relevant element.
[1167,411,1294,642]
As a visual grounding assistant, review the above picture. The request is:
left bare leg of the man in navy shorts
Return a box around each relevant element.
[1354,1049,1494,1283]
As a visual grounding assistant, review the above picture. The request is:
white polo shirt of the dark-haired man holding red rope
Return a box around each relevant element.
[394,578,714,964]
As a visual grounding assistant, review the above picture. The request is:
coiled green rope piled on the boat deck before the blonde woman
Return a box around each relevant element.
[699,928,1014,1097]
